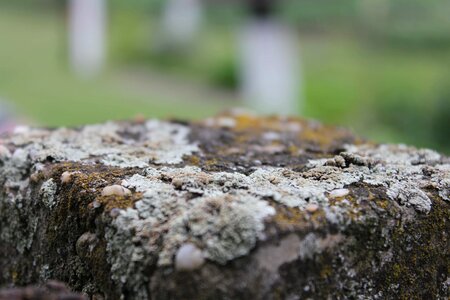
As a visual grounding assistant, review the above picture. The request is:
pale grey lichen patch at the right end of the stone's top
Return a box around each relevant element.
[306,145,450,213]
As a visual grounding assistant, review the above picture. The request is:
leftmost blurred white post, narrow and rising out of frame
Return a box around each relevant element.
[69,0,106,78]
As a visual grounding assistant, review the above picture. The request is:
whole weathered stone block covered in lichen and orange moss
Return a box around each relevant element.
[0,113,450,299]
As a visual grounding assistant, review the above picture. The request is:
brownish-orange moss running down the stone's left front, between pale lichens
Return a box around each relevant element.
[39,162,142,291]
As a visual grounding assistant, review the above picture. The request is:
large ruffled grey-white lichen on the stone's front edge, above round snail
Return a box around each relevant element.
[106,167,275,291]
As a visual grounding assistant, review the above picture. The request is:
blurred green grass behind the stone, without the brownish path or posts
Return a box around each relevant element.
[0,4,450,152]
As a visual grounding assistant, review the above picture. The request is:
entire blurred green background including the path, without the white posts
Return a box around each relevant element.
[0,0,450,153]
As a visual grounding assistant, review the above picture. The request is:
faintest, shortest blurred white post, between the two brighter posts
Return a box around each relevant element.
[162,0,203,48]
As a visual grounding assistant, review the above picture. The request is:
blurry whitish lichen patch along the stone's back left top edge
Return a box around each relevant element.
[3,120,198,168]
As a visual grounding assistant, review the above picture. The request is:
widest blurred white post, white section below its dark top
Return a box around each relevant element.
[239,17,302,115]
